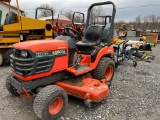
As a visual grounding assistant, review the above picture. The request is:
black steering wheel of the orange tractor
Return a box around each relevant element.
[64,27,80,38]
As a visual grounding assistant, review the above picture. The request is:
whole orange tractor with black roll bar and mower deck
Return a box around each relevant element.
[6,1,116,120]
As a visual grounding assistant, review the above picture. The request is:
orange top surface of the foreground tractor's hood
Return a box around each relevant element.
[13,39,67,52]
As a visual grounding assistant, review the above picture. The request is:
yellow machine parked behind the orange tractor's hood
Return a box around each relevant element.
[0,0,53,65]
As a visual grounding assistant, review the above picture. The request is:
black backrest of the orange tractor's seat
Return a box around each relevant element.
[85,25,103,43]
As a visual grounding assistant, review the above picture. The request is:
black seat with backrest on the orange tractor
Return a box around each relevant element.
[76,25,103,47]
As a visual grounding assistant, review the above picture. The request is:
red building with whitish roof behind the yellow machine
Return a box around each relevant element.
[40,15,72,26]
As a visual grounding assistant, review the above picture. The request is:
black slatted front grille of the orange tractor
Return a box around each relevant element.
[10,50,54,76]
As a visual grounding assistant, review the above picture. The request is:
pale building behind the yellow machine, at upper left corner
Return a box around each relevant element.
[0,1,24,25]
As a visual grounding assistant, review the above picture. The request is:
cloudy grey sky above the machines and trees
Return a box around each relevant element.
[11,0,160,22]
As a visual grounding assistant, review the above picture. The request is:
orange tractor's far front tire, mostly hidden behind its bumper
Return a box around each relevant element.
[6,73,19,96]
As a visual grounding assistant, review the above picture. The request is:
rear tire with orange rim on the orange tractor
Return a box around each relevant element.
[92,57,115,82]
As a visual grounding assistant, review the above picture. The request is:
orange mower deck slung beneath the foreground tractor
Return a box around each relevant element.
[55,77,109,102]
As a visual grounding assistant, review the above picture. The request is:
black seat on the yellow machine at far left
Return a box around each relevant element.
[0,12,17,31]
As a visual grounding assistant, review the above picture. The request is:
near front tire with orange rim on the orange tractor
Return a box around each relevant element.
[33,85,68,120]
